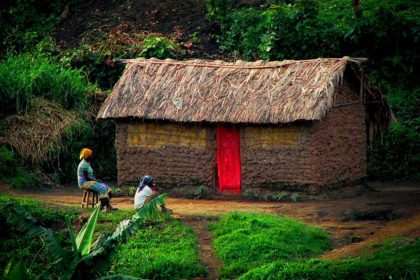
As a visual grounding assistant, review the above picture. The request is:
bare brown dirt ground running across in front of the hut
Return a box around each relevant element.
[0,184,420,260]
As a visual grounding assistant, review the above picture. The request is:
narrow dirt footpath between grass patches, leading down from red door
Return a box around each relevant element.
[180,216,222,279]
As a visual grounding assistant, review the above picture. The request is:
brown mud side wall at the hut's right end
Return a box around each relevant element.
[307,103,366,188]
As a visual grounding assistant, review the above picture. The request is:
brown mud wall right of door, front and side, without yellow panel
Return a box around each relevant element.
[241,103,366,192]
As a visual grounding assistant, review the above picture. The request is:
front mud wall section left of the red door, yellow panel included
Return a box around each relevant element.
[116,121,216,187]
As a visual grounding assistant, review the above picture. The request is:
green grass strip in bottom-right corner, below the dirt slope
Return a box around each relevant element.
[239,239,420,280]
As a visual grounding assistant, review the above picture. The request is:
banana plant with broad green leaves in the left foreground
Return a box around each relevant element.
[0,194,167,280]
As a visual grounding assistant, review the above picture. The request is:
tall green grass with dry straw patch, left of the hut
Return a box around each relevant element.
[0,54,116,187]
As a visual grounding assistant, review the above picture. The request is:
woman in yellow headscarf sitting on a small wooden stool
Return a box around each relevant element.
[77,148,117,211]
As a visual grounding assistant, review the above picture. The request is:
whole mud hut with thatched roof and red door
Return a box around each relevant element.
[98,58,391,192]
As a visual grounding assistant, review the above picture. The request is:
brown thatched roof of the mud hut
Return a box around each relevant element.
[98,58,389,128]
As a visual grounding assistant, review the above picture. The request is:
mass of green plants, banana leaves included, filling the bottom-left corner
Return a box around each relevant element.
[0,195,176,279]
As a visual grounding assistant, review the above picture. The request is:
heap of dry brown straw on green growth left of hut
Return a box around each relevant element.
[5,98,77,163]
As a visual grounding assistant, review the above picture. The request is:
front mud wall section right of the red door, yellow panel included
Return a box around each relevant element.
[241,124,312,189]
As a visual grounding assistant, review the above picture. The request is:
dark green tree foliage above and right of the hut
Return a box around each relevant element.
[206,0,420,179]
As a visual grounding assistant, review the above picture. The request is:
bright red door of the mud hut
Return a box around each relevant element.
[216,125,241,193]
